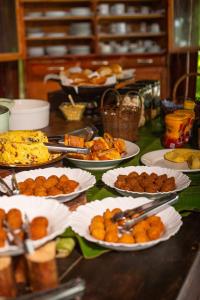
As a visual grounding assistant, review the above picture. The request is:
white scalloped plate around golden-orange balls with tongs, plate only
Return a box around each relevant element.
[69,197,182,251]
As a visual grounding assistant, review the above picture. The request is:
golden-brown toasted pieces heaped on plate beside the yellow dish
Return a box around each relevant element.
[64,133,126,160]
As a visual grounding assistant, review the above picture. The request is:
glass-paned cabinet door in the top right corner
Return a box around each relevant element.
[168,0,200,52]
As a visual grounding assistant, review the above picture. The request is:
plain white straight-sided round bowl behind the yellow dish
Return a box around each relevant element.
[9,99,50,130]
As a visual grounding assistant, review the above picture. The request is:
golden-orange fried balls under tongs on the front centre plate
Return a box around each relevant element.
[89,208,165,244]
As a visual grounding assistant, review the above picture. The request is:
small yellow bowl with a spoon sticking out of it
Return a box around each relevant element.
[59,102,86,121]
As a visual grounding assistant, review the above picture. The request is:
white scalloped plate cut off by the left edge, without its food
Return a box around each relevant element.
[0,195,71,255]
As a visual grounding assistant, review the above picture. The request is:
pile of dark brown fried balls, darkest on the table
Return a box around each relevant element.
[114,172,176,193]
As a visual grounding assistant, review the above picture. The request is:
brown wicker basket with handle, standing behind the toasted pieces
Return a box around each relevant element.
[101,89,142,141]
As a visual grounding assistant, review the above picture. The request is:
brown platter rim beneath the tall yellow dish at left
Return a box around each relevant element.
[0,153,66,170]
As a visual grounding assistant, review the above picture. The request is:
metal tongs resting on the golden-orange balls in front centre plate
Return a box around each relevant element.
[112,193,179,231]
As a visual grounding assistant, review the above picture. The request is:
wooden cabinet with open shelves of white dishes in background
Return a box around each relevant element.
[20,0,168,99]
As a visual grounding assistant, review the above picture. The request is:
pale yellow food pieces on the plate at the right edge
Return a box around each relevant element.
[164,148,200,169]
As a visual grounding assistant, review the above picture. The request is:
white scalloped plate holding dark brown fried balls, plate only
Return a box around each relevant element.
[102,166,191,199]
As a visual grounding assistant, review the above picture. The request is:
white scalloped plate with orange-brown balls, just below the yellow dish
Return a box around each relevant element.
[4,167,96,202]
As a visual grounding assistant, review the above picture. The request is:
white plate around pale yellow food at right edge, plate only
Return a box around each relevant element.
[141,149,200,172]
